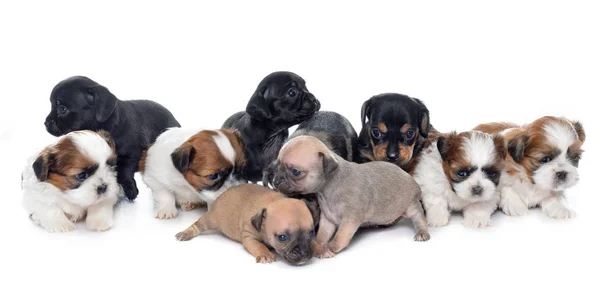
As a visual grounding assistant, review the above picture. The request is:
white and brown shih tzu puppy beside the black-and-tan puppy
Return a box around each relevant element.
[412,131,507,228]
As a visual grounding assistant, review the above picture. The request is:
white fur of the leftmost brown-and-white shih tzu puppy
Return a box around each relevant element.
[22,131,122,232]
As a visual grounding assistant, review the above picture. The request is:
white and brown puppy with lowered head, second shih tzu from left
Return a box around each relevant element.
[139,128,246,219]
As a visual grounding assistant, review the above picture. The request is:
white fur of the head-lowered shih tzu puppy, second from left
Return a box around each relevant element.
[143,128,241,219]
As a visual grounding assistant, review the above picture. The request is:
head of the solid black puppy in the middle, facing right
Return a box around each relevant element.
[246,72,321,127]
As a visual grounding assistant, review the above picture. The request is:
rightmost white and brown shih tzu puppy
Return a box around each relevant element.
[475,116,585,219]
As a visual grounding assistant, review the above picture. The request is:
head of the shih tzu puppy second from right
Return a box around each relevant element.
[437,131,507,203]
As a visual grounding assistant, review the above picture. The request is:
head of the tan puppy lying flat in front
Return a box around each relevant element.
[251,198,315,265]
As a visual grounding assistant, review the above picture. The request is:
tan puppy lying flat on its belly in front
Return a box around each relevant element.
[175,184,318,265]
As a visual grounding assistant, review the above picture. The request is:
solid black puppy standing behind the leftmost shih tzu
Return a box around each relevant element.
[45,76,180,200]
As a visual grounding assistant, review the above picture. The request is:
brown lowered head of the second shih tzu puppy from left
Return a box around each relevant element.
[171,129,246,192]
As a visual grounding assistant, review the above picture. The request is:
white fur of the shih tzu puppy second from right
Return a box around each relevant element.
[413,132,500,228]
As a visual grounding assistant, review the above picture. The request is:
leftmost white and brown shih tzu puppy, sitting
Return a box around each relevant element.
[21,130,123,232]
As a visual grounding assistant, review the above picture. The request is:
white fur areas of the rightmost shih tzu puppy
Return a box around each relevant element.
[499,121,579,219]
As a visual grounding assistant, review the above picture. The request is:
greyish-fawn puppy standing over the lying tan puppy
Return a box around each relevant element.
[273,136,429,258]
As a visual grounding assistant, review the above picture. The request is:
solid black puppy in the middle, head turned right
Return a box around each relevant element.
[222,71,321,183]
